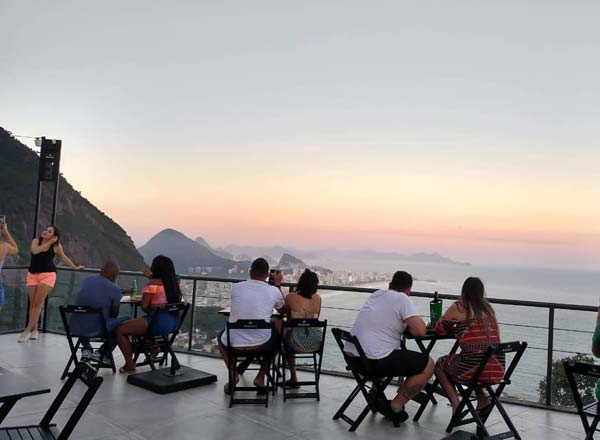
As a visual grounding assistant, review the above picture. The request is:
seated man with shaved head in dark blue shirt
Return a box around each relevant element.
[70,262,129,363]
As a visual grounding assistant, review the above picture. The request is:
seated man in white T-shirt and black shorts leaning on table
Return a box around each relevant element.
[345,271,434,422]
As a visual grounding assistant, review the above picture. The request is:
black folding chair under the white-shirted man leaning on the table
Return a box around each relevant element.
[331,328,398,432]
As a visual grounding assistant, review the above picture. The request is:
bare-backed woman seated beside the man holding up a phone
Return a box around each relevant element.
[283,269,322,388]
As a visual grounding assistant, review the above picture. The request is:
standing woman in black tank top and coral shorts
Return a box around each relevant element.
[18,226,83,342]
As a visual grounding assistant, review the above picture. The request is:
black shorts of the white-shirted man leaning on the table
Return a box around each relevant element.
[350,350,429,377]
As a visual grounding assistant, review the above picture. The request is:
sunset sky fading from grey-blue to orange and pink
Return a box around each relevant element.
[0,0,600,270]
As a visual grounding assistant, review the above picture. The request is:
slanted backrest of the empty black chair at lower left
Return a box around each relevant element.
[40,362,104,440]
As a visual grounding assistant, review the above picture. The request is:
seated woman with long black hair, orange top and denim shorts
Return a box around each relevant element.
[116,255,181,373]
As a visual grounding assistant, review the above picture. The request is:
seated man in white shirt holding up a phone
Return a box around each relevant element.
[218,258,283,394]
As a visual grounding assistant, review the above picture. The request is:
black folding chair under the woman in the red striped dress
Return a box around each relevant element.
[446,341,527,440]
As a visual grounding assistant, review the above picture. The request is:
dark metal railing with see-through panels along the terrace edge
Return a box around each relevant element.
[0,266,596,408]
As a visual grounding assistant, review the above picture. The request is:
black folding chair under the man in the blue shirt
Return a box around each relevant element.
[58,305,117,380]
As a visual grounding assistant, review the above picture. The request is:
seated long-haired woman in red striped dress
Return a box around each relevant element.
[435,277,504,414]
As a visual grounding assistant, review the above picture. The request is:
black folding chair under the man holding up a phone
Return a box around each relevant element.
[224,319,277,408]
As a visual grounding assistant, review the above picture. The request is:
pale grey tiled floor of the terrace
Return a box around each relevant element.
[0,335,584,440]
